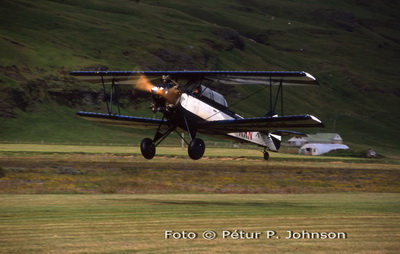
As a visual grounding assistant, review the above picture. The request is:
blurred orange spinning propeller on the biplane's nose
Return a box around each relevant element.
[136,75,180,104]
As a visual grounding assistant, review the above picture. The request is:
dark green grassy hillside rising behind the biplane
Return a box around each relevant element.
[0,0,400,154]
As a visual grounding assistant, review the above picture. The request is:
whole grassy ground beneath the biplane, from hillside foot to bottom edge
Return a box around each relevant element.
[0,144,400,253]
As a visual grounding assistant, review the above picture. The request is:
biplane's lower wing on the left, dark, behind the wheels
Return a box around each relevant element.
[76,111,168,129]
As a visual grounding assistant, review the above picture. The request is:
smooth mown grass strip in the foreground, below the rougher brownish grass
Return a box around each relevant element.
[0,193,400,253]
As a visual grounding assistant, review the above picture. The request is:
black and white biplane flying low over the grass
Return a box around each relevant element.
[71,71,324,160]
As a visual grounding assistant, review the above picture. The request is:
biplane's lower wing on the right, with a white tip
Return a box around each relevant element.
[197,115,324,134]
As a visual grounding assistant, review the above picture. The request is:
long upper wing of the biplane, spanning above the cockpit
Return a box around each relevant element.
[71,71,319,86]
